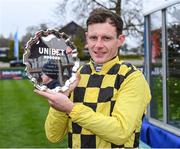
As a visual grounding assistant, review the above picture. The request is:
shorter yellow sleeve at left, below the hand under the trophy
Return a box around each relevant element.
[45,107,68,143]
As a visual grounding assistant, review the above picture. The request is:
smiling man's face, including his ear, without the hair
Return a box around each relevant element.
[86,22,124,64]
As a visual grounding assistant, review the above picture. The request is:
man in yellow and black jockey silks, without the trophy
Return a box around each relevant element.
[36,9,151,148]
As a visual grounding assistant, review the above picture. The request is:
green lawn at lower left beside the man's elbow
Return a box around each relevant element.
[0,80,67,148]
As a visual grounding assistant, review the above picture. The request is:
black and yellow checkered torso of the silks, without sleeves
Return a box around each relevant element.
[68,60,139,148]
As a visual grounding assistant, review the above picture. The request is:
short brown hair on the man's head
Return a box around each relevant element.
[86,8,123,35]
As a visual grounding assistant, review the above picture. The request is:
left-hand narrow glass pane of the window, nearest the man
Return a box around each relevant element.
[150,11,163,120]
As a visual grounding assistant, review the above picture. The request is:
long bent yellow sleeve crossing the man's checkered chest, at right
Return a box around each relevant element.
[69,71,151,145]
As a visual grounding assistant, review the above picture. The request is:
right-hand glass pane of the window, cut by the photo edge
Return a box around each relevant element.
[167,4,180,128]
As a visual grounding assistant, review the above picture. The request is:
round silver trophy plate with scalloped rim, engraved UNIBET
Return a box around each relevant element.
[23,30,80,92]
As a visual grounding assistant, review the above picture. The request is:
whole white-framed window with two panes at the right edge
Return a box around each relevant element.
[145,0,180,136]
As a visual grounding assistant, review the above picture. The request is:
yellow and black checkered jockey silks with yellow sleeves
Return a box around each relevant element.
[46,57,150,148]
